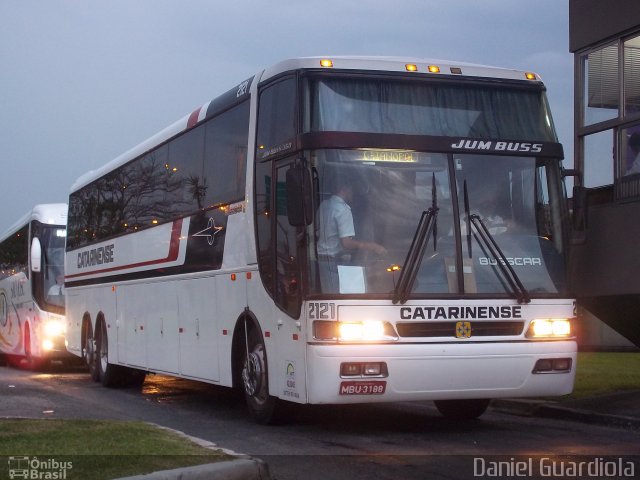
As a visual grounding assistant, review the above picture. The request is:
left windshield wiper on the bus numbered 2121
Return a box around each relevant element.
[393,174,438,305]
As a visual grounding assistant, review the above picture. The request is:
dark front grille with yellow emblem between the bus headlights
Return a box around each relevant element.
[396,321,524,338]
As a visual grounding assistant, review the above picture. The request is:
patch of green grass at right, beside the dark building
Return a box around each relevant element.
[566,352,640,399]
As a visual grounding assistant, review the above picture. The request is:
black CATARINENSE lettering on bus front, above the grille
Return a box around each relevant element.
[400,305,522,320]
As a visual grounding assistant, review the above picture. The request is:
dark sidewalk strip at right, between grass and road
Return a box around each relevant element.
[491,390,640,430]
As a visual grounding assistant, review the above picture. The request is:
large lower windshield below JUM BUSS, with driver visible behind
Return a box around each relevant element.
[307,149,565,298]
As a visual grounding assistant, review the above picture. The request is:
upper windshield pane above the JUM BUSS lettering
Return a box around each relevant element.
[305,78,557,142]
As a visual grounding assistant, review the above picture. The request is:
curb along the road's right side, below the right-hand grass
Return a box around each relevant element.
[491,399,640,430]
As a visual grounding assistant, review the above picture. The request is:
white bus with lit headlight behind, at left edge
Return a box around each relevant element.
[0,204,68,368]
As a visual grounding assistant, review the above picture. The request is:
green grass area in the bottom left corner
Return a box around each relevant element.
[0,419,232,480]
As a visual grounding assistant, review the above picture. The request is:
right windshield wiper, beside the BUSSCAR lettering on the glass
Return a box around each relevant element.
[464,180,531,303]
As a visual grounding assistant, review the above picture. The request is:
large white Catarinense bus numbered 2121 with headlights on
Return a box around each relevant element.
[66,58,576,422]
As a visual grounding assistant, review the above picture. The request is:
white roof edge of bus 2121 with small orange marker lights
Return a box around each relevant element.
[71,56,541,192]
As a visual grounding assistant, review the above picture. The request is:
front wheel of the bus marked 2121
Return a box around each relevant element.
[242,327,278,424]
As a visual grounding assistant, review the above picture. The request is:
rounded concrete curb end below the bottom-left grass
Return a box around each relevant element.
[117,458,271,480]
